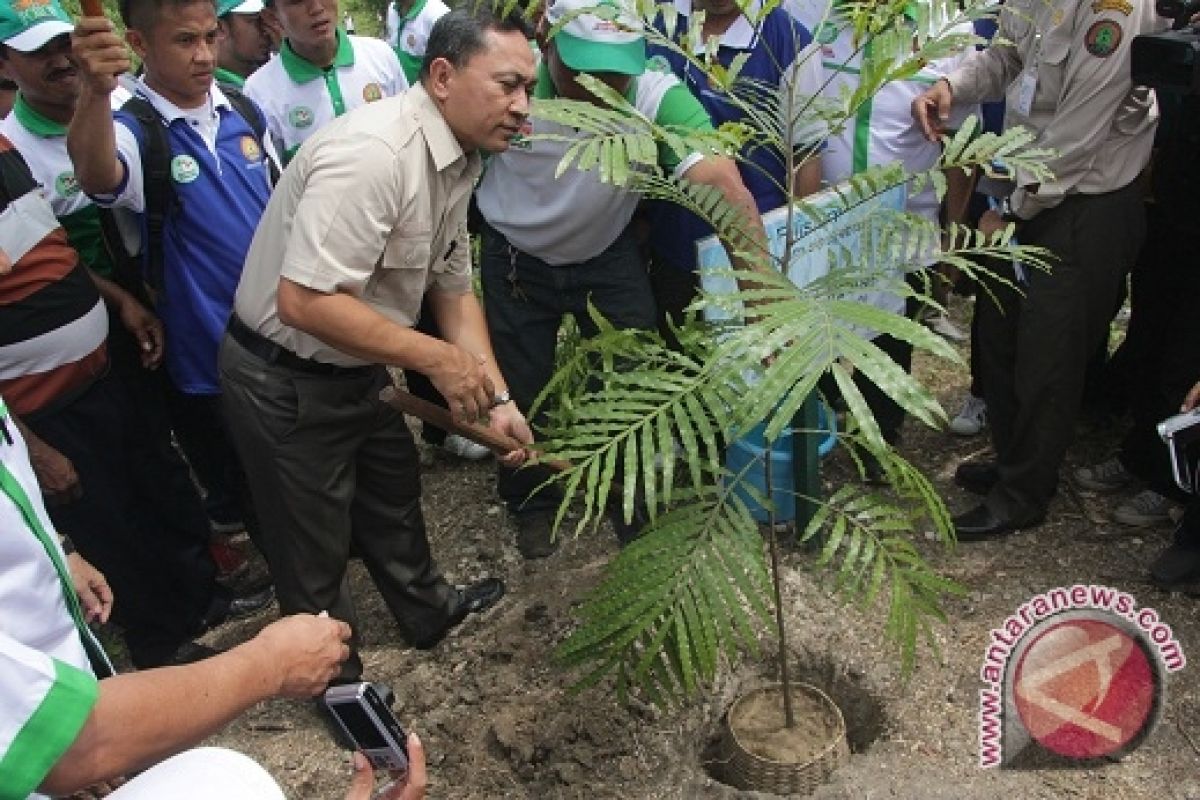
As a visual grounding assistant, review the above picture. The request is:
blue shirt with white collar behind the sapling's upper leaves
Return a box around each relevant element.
[647,0,821,270]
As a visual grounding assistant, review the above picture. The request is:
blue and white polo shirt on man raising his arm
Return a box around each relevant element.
[96,84,270,395]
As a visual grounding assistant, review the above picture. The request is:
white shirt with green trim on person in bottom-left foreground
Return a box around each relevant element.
[0,399,100,800]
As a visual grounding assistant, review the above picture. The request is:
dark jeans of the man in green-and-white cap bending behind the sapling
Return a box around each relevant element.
[480,225,655,513]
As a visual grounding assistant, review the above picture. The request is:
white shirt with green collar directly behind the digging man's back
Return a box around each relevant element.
[246,28,408,163]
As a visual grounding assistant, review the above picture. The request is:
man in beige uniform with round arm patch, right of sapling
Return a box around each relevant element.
[912,0,1164,541]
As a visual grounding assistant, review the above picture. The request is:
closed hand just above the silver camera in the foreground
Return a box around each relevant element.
[250,614,350,697]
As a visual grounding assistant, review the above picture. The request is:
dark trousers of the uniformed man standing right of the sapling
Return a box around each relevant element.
[976,185,1145,524]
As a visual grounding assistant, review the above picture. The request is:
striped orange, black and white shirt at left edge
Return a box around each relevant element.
[0,136,108,416]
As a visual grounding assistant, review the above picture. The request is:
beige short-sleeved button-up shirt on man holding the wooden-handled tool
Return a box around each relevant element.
[234,85,480,367]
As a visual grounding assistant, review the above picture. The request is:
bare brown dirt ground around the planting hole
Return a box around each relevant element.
[201,301,1200,800]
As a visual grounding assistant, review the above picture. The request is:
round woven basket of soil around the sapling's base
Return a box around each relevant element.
[719,684,850,795]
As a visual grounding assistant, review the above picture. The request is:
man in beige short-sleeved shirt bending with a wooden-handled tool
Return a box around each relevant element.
[220,12,534,681]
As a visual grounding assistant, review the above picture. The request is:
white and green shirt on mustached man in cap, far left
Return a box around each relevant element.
[0,90,128,278]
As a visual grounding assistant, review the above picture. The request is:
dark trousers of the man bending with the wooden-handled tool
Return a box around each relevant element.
[220,335,457,680]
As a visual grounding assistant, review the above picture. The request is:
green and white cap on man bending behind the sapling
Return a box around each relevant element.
[546,0,646,76]
